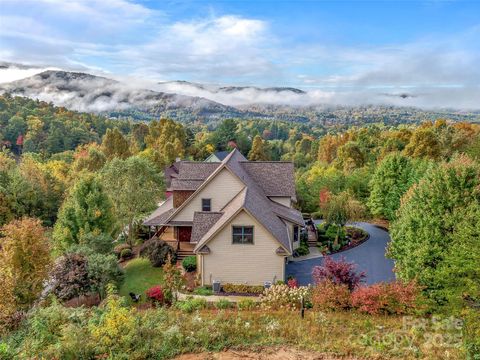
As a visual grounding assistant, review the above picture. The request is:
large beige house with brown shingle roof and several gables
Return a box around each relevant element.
[144,149,305,285]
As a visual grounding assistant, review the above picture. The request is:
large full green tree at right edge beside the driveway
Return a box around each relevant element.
[388,156,480,304]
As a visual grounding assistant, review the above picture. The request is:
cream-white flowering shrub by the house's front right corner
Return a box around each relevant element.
[260,285,310,310]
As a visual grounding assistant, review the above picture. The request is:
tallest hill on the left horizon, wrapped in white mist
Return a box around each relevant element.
[0,70,248,120]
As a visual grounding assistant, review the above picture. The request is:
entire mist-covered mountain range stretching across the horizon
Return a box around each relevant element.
[0,63,480,127]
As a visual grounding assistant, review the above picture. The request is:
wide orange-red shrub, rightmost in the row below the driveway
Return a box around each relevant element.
[351,281,420,314]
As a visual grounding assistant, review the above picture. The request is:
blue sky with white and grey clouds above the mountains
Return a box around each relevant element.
[0,0,480,107]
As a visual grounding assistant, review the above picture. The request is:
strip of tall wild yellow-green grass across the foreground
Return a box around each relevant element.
[4,306,465,360]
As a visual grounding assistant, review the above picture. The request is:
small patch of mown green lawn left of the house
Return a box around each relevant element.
[120,258,163,302]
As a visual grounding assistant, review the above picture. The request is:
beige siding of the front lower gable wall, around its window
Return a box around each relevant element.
[199,210,285,285]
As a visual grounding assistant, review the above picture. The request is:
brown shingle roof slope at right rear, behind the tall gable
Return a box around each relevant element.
[241,161,295,198]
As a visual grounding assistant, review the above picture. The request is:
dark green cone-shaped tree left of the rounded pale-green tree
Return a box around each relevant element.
[53,175,115,251]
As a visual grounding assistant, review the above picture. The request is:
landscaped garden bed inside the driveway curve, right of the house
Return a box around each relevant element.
[317,223,370,255]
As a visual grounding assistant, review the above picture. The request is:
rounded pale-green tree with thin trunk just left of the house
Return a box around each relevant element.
[102,156,164,244]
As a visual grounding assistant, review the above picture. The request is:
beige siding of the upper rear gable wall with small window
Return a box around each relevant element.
[172,169,245,221]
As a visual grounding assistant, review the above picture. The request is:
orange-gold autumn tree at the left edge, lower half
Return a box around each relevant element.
[0,218,51,322]
